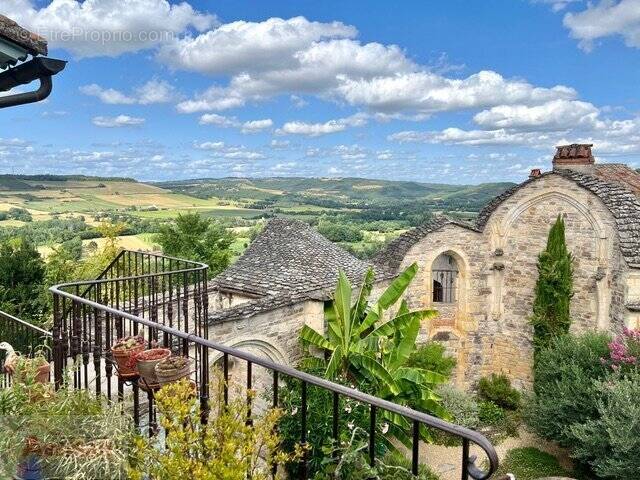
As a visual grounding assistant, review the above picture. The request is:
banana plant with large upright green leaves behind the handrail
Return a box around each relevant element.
[300,263,446,416]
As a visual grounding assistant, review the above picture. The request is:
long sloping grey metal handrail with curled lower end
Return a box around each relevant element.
[49,280,499,480]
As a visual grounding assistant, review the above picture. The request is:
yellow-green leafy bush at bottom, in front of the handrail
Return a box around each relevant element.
[128,375,302,480]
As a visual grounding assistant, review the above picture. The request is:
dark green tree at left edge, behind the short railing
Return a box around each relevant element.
[0,238,47,323]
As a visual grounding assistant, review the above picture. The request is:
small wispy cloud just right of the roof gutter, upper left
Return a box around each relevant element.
[80,79,177,105]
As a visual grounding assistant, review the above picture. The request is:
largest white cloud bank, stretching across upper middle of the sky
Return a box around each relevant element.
[169,17,576,119]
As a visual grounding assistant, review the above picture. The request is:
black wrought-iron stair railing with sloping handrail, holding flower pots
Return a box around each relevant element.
[45,251,498,480]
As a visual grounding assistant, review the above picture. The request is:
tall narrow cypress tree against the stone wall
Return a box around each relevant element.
[531,215,573,356]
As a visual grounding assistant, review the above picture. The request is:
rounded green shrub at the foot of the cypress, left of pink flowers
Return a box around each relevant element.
[525,333,611,447]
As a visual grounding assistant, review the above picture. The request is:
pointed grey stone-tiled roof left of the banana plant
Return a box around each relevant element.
[212,218,369,296]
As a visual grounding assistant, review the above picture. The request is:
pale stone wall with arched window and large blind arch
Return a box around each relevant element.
[401,175,624,387]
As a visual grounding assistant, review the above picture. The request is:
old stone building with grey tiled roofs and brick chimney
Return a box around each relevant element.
[210,145,640,386]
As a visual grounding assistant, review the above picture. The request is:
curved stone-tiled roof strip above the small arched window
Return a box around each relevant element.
[374,216,476,273]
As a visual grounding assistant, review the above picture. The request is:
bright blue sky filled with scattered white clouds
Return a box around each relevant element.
[0,0,640,184]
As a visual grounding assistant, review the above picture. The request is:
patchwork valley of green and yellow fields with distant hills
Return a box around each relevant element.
[0,175,511,256]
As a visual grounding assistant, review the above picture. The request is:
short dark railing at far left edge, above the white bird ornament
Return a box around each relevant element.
[0,311,52,388]
